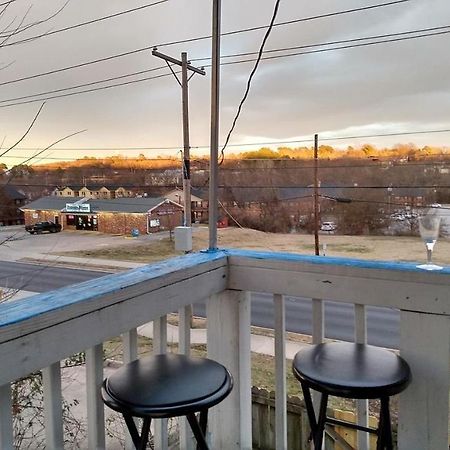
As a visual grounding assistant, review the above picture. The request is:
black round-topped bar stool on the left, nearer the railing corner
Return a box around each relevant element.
[101,354,233,450]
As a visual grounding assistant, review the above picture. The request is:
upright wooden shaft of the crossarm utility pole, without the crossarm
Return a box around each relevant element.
[181,52,192,227]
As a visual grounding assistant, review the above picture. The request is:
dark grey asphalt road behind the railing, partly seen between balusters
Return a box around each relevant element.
[0,262,399,348]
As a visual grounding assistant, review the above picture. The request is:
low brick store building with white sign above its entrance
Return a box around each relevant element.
[22,196,183,234]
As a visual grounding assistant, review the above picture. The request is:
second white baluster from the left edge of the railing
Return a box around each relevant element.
[42,361,64,450]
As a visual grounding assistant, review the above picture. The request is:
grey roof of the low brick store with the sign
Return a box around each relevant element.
[22,195,181,213]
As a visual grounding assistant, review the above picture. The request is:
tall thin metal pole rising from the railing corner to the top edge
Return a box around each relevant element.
[209,0,221,250]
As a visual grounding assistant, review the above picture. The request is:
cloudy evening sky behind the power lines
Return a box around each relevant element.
[0,0,450,165]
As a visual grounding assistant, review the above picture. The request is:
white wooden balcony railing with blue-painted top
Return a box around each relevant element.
[0,250,450,450]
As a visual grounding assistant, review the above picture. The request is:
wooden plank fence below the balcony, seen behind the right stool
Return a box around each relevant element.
[252,387,386,450]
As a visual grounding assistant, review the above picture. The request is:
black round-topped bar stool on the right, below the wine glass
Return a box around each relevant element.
[292,342,411,450]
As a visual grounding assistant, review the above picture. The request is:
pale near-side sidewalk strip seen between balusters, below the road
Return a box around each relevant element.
[138,322,309,359]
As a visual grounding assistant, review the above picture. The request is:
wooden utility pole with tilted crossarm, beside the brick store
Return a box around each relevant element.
[152,48,206,227]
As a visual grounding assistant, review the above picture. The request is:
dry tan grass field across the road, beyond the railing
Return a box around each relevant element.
[58,227,450,265]
